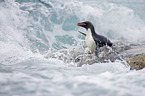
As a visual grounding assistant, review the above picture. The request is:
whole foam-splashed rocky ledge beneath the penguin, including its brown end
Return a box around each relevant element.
[45,41,145,70]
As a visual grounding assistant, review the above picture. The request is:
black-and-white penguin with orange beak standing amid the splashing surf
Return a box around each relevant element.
[77,21,113,57]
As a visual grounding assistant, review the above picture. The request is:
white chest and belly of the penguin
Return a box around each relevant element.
[86,29,96,51]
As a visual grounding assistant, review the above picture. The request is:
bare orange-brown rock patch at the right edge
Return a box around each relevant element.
[125,53,145,70]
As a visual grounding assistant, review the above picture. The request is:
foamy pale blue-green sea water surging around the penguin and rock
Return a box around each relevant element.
[0,0,145,96]
